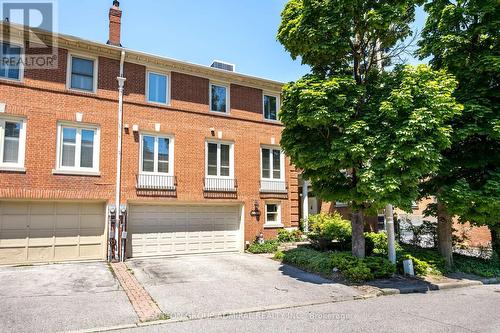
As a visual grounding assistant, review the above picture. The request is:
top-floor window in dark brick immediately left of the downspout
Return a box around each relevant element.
[69,56,97,92]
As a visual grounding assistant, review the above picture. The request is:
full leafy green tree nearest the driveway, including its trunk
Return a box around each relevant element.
[278,0,460,257]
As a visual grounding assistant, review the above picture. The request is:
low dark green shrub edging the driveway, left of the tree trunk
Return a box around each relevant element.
[282,247,333,277]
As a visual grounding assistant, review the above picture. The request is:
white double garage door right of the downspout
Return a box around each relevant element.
[127,205,240,257]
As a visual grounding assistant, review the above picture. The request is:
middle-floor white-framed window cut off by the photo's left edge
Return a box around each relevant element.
[0,119,26,169]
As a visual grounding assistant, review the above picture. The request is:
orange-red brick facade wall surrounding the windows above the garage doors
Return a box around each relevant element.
[0,44,299,240]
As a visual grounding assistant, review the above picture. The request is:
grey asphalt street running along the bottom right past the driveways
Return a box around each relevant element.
[125,285,500,333]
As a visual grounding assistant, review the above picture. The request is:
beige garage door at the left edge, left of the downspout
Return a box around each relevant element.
[0,201,106,264]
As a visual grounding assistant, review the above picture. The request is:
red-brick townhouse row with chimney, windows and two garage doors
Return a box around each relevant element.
[0,1,299,264]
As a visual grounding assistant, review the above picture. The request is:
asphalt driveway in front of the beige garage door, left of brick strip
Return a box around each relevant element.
[0,262,138,332]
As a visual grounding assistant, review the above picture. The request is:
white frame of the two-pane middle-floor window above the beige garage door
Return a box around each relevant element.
[53,122,101,175]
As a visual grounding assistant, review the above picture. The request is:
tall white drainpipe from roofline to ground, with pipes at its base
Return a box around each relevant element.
[114,50,127,261]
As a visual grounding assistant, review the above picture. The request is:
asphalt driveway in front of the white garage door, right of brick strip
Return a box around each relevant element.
[127,254,358,318]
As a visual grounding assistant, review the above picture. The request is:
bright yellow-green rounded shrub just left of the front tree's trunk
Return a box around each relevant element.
[308,213,352,249]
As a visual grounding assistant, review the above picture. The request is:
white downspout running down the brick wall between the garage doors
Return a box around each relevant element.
[115,50,126,259]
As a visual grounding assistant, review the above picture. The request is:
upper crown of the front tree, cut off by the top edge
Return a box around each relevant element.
[278,0,422,71]
